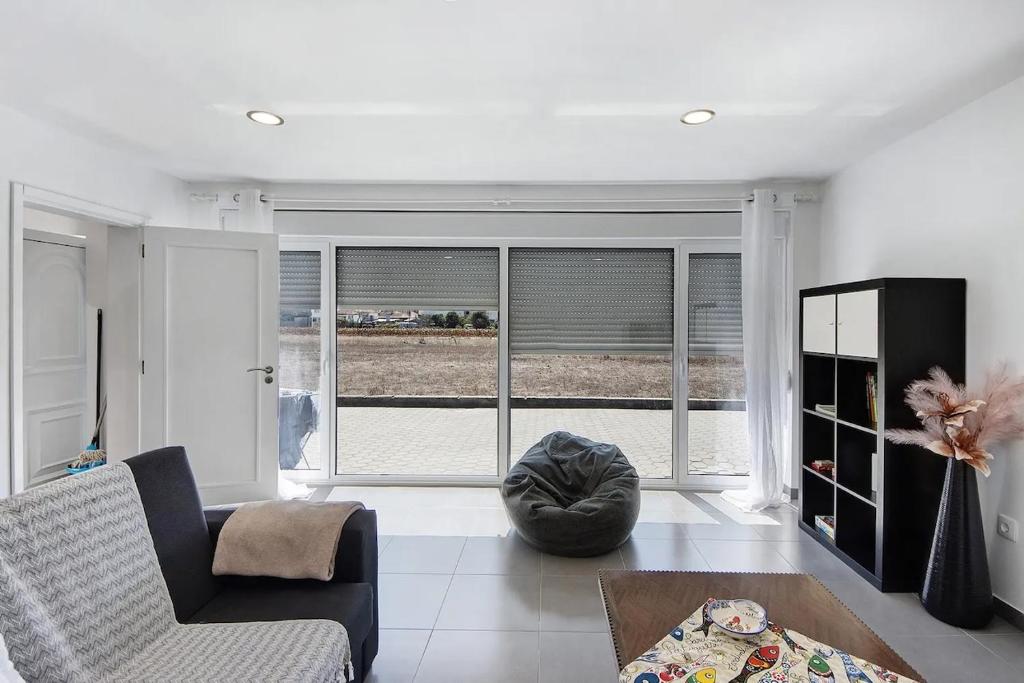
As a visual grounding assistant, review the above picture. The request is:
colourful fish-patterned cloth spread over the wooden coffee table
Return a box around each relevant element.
[618,598,914,683]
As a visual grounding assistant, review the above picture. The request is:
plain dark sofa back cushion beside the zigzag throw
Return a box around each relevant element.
[125,446,218,622]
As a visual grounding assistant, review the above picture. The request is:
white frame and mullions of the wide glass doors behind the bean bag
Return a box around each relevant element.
[280,229,793,490]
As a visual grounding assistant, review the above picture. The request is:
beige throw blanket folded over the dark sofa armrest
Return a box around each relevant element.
[213,501,364,581]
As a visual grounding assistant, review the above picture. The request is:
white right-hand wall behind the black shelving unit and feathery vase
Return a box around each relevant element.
[821,79,1024,609]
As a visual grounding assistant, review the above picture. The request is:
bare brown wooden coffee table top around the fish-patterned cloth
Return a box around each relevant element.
[598,569,925,681]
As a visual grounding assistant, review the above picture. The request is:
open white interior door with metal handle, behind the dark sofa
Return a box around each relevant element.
[140,227,279,505]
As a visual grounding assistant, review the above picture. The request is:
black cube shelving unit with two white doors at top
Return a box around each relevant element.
[799,278,967,592]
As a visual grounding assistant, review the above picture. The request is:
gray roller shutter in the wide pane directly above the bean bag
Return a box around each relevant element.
[509,248,675,354]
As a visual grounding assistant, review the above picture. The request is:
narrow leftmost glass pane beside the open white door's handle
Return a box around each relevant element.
[278,251,322,470]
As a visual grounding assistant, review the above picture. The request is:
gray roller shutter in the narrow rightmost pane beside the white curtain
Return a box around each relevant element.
[687,254,743,355]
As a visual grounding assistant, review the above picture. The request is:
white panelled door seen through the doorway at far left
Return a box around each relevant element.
[20,230,93,486]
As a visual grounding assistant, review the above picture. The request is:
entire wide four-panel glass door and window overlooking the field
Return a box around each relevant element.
[280,232,784,486]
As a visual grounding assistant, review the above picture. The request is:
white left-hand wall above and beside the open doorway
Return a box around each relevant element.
[0,102,188,496]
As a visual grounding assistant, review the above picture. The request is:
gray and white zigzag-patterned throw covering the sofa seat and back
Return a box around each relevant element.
[0,464,351,682]
